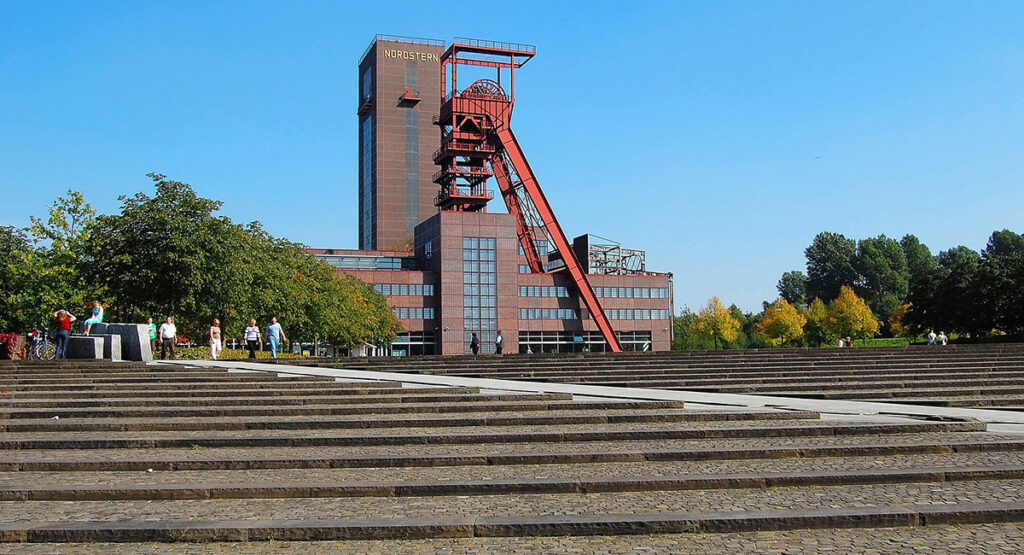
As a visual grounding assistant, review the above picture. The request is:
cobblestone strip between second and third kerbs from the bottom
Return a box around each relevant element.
[8,453,1024,487]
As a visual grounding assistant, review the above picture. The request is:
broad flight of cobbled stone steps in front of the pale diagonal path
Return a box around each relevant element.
[0,356,1024,550]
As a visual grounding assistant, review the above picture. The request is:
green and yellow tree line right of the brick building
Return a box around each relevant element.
[673,229,1024,349]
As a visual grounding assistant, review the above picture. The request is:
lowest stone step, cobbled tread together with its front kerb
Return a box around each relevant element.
[0,476,1024,542]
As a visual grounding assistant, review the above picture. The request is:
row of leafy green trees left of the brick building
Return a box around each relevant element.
[0,174,400,344]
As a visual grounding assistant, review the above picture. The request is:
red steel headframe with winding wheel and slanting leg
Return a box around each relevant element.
[434,38,623,352]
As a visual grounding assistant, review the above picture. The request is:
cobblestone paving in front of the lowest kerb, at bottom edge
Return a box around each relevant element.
[0,523,1024,555]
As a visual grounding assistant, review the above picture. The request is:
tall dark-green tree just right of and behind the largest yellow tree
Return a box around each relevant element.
[856,234,910,321]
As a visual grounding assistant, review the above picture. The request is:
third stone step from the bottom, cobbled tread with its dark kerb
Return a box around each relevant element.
[0,433,1024,472]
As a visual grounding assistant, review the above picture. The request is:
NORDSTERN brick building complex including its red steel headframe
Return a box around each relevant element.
[309,35,673,355]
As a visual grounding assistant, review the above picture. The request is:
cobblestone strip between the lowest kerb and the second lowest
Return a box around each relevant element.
[0,480,1024,522]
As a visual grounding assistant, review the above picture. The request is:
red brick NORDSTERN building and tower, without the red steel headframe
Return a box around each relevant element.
[310,36,673,355]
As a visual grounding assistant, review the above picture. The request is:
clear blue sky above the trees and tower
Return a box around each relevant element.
[0,0,1024,311]
